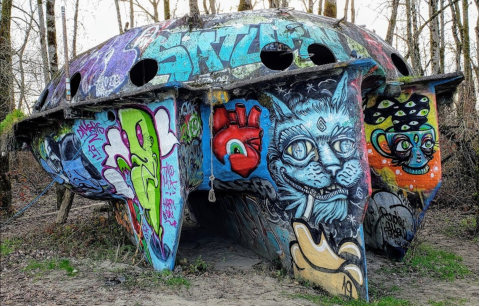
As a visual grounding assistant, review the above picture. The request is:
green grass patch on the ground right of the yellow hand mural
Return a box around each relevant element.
[382,244,471,282]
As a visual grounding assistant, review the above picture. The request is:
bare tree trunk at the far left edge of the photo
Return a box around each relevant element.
[0,0,13,214]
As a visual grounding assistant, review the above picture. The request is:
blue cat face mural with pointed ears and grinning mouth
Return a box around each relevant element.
[268,72,363,225]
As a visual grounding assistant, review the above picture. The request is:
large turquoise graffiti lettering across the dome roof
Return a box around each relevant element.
[143,21,346,82]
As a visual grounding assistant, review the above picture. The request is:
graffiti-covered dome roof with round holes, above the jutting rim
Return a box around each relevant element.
[34,9,411,113]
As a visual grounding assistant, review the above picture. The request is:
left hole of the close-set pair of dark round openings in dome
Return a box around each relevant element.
[260,42,293,70]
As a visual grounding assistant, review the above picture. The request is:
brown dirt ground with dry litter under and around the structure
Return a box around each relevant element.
[0,157,479,306]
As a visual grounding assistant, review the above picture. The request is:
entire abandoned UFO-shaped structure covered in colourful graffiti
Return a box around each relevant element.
[17,9,462,299]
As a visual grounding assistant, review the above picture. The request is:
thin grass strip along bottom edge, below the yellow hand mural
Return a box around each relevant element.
[289,294,412,306]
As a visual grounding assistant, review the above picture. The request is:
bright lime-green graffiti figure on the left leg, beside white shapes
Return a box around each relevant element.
[117,108,163,240]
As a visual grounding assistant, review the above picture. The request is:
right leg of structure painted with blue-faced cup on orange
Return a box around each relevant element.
[364,76,457,260]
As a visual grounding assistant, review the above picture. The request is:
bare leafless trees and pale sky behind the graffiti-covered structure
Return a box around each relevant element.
[0,0,479,231]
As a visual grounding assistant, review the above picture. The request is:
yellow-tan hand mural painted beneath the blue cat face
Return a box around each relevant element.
[290,221,364,299]
